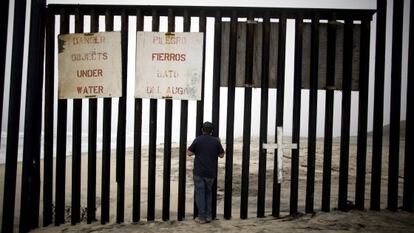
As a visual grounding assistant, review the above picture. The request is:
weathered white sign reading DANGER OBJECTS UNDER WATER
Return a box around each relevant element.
[58,32,122,99]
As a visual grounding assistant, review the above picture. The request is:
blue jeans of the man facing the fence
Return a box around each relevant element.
[194,176,214,221]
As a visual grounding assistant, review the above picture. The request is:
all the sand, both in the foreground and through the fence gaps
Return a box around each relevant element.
[0,134,414,232]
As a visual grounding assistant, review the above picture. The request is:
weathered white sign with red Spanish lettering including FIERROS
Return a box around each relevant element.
[135,32,204,100]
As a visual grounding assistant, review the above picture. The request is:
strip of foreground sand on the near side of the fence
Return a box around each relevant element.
[29,211,414,233]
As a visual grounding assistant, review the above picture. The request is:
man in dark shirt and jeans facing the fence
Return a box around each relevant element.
[187,121,224,224]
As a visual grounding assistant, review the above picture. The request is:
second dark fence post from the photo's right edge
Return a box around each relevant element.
[387,0,404,211]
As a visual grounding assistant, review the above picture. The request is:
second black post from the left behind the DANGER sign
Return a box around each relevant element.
[71,8,83,225]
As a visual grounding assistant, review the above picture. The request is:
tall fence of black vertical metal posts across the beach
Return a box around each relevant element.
[0,0,414,232]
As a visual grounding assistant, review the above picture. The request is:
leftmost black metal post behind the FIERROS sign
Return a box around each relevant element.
[132,9,144,222]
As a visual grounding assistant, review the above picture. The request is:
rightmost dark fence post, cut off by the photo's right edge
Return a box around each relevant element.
[403,0,414,212]
